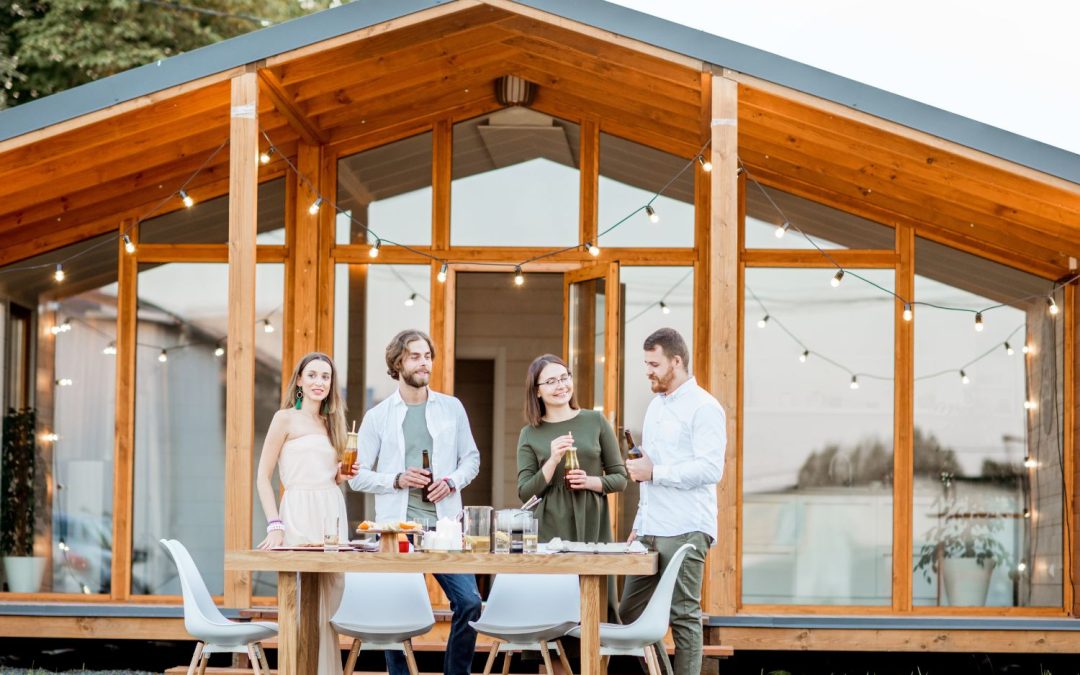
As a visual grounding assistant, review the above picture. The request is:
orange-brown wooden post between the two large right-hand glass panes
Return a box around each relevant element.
[892,226,919,611]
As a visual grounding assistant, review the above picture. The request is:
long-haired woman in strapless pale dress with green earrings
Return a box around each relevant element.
[256,352,360,675]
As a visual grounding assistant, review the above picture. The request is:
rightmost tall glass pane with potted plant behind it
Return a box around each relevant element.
[913,240,1065,607]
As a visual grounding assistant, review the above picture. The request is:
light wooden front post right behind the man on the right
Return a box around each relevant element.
[704,76,741,615]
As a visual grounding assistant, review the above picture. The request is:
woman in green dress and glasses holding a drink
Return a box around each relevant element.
[517,354,626,542]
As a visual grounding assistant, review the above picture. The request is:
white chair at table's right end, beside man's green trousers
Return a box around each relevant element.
[569,543,693,675]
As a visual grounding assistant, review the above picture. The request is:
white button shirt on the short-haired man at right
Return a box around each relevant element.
[634,377,727,541]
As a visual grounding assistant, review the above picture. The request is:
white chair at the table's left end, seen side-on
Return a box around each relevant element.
[161,539,278,675]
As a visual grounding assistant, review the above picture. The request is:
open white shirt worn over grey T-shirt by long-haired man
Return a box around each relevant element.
[349,389,480,523]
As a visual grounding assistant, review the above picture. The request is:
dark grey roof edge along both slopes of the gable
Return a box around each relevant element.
[0,0,1080,184]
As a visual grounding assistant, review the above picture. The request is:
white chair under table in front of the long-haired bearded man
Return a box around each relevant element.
[330,572,435,675]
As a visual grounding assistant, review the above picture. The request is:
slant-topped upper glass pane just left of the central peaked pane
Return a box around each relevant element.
[336,132,431,246]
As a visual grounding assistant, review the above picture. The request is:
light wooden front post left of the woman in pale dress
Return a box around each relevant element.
[225,69,259,607]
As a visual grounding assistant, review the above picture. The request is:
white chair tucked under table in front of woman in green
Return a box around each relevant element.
[469,575,581,675]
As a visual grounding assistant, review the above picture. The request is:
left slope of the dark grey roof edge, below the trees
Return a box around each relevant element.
[0,0,453,141]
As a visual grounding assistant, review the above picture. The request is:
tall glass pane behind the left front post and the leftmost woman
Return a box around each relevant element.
[132,262,283,595]
